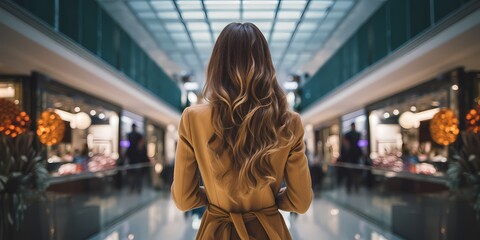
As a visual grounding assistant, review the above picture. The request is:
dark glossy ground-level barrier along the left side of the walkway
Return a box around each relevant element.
[12,163,163,240]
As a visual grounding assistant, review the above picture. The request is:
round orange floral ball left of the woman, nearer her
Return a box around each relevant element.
[37,110,65,146]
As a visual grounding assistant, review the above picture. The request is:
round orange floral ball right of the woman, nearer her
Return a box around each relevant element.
[430,109,460,146]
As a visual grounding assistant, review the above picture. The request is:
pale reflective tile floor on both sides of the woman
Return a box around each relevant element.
[90,196,400,240]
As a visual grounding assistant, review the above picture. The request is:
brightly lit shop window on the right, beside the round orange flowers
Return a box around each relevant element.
[369,81,458,175]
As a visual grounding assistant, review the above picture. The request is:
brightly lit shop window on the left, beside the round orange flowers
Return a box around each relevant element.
[42,91,119,175]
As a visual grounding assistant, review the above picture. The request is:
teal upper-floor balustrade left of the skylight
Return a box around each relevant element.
[0,0,182,110]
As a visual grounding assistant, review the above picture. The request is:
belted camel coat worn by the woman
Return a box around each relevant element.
[171,104,313,240]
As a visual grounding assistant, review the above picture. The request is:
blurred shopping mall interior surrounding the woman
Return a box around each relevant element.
[0,0,480,240]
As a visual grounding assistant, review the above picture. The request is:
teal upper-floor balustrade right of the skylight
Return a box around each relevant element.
[299,0,480,110]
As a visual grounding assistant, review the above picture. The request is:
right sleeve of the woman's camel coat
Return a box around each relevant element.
[277,116,313,213]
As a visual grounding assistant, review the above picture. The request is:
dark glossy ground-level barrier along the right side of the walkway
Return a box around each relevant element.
[311,163,480,240]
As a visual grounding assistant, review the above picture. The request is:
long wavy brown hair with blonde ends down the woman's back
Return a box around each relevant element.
[203,23,294,195]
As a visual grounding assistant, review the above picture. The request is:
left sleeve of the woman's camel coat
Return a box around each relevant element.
[171,108,208,211]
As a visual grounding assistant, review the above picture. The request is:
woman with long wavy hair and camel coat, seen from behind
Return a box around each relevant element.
[172,23,313,240]
